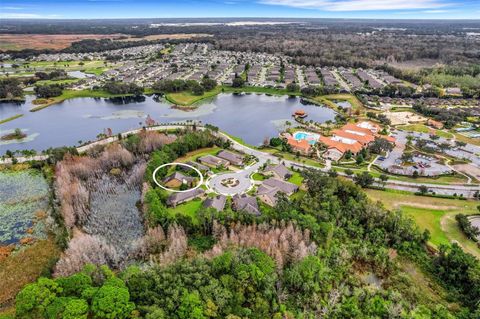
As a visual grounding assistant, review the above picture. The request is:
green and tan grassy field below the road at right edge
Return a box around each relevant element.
[366,190,480,258]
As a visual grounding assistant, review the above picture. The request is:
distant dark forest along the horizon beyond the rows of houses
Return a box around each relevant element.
[4,19,480,68]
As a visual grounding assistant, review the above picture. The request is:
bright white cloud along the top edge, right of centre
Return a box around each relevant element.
[260,0,448,11]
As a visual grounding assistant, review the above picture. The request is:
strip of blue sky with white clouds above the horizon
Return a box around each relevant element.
[0,0,480,19]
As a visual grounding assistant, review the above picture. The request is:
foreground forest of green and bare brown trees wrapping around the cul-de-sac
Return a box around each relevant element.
[6,130,480,319]
